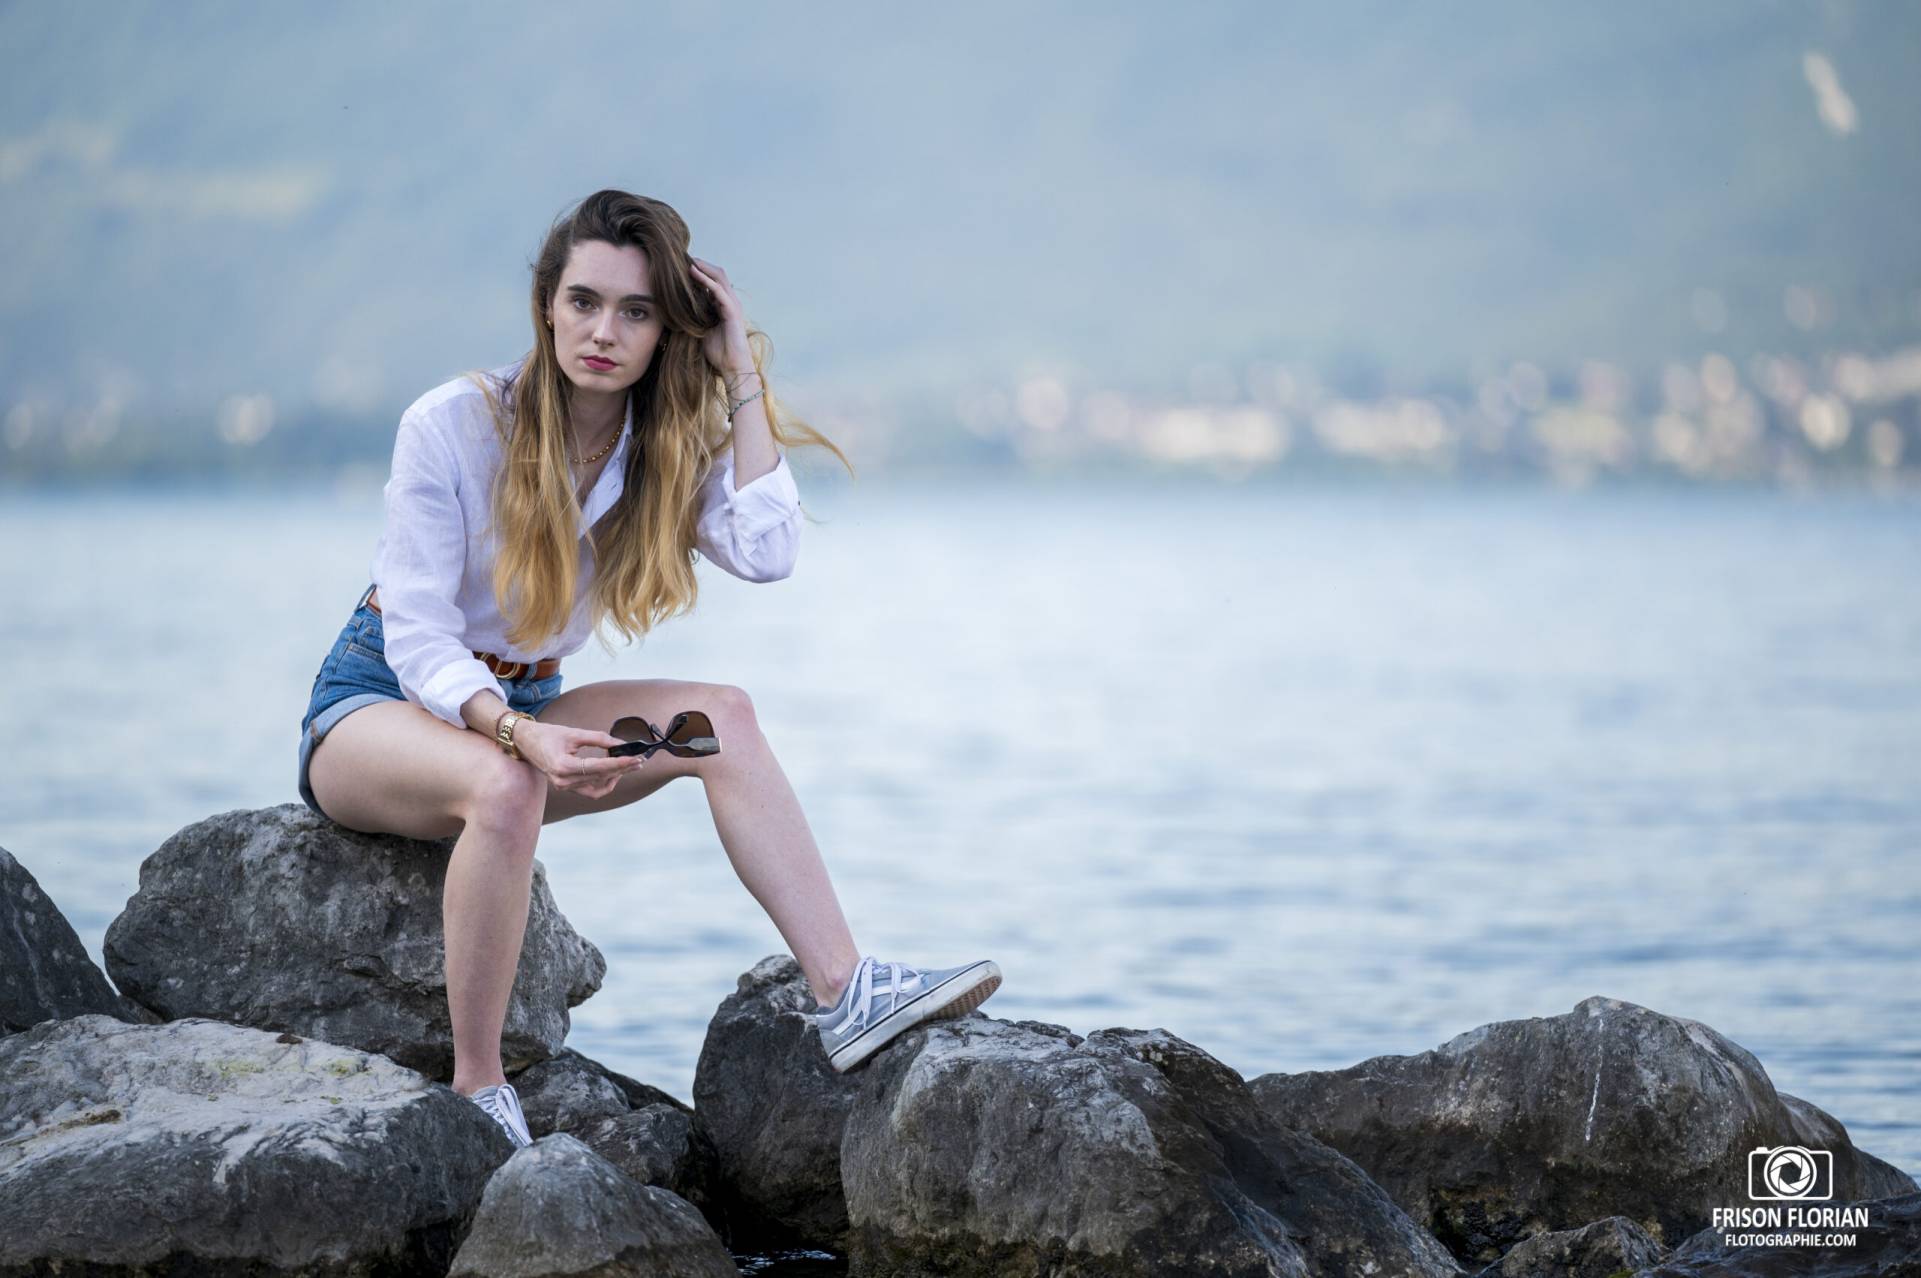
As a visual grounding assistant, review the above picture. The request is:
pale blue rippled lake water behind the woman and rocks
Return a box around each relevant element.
[0,477,1921,1174]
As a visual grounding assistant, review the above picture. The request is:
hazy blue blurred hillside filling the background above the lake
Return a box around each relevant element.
[0,0,1921,484]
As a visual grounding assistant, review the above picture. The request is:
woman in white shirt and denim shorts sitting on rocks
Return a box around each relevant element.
[300,190,1001,1145]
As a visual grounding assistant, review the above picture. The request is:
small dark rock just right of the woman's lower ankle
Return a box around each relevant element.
[513,1047,722,1222]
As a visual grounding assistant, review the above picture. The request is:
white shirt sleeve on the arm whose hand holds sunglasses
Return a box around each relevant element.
[373,413,507,728]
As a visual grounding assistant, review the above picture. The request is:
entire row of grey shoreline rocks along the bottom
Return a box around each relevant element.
[0,803,1921,1278]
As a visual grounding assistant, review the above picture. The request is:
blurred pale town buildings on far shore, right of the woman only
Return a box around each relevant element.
[849,328,1921,486]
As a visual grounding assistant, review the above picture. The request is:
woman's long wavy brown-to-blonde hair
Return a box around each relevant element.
[467,190,853,651]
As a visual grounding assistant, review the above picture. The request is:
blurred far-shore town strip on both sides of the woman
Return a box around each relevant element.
[0,328,1921,490]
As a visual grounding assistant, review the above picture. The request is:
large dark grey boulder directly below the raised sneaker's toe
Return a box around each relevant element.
[841,1013,1458,1278]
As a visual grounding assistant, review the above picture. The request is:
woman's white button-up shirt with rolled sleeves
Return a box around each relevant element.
[371,361,801,728]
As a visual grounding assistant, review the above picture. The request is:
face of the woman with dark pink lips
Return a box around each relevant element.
[547,240,663,394]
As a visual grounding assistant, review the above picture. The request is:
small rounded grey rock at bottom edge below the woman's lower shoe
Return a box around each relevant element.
[451,1132,740,1278]
